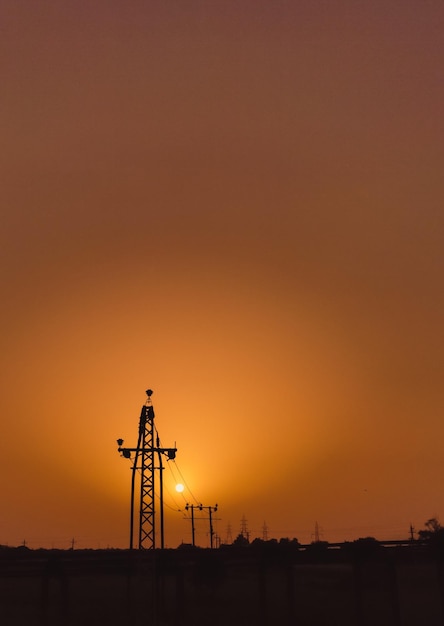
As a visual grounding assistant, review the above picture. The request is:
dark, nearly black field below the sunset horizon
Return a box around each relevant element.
[0,546,444,626]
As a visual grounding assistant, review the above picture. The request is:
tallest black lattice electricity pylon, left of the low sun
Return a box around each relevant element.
[117,389,177,550]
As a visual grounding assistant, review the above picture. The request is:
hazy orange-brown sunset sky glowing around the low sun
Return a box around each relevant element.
[0,0,444,548]
